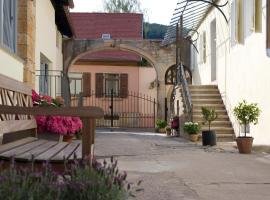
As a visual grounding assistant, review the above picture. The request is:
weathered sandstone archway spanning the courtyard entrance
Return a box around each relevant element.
[62,39,190,118]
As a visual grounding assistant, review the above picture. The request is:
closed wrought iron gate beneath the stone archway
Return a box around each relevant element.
[72,91,157,128]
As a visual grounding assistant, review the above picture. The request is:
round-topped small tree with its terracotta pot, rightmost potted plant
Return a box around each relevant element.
[233,100,260,154]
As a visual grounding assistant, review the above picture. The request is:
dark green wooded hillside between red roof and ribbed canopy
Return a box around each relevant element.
[143,22,167,39]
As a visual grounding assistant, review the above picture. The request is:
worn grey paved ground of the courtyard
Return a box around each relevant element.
[96,130,270,200]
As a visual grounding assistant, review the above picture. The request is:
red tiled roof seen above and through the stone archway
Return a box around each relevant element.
[70,13,143,61]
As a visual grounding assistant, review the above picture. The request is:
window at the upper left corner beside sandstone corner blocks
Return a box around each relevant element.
[0,0,17,53]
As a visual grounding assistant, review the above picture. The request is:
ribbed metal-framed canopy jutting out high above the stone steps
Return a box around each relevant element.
[162,0,228,46]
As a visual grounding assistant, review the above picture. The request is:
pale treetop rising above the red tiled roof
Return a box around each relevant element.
[103,0,143,13]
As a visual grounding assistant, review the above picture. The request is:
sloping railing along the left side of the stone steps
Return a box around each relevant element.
[178,63,193,121]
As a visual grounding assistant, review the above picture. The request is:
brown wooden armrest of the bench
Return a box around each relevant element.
[0,105,104,118]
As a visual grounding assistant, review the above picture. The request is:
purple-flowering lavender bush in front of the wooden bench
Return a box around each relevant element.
[0,159,141,200]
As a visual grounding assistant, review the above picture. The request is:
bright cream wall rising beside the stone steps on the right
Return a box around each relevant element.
[193,0,270,144]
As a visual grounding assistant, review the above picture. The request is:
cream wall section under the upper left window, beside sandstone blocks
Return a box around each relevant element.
[0,47,23,81]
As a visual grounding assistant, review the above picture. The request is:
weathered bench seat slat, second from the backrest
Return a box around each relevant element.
[0,140,46,158]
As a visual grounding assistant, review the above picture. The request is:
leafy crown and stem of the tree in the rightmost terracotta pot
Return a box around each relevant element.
[233,100,261,136]
